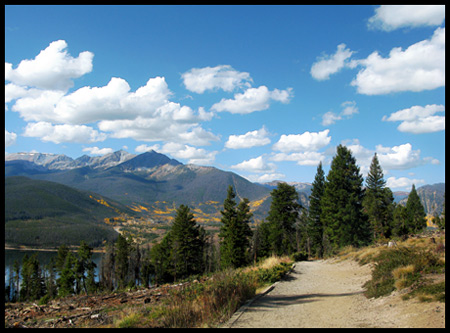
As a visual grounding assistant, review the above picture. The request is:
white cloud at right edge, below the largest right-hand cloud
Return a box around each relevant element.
[383,104,445,134]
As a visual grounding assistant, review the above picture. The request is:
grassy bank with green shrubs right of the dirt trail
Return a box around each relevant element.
[340,237,445,302]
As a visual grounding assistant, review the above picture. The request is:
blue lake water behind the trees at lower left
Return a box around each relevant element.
[5,250,102,286]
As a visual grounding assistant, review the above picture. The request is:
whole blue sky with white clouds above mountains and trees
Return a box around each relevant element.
[5,5,445,191]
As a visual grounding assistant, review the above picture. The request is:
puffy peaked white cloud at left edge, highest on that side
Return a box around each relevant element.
[5,40,94,91]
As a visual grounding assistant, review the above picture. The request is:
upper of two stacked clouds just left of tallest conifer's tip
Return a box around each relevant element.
[272,129,331,153]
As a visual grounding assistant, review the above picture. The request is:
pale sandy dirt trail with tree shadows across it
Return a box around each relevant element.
[224,260,445,328]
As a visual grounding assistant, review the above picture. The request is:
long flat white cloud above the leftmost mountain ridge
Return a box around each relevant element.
[23,122,106,143]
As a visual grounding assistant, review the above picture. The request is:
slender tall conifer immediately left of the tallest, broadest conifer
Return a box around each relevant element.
[308,162,325,258]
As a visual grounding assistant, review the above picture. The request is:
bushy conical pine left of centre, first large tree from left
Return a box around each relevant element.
[171,205,205,280]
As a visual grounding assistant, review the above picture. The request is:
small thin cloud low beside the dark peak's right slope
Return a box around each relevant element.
[158,142,217,165]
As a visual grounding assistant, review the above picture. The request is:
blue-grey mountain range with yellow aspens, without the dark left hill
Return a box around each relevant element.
[5,150,445,246]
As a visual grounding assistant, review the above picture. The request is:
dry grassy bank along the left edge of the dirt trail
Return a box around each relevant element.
[112,257,293,328]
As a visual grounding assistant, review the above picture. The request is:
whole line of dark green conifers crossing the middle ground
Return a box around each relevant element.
[5,145,445,301]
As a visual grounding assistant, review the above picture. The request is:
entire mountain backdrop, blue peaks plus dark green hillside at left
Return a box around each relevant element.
[5,150,445,246]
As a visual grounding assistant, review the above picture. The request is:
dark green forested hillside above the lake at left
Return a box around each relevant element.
[5,176,135,247]
